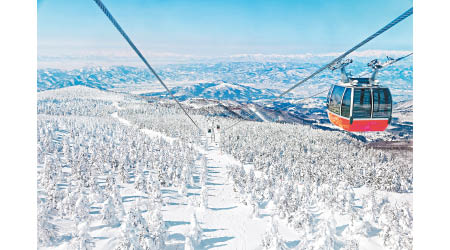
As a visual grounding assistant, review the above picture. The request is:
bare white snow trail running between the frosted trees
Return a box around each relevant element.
[109,104,299,249]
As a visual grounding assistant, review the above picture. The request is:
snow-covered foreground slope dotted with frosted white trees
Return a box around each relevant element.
[37,86,413,249]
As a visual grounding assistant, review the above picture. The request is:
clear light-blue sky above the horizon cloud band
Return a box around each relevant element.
[38,0,413,56]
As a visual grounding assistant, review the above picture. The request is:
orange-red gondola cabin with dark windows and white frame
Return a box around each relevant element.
[327,78,392,132]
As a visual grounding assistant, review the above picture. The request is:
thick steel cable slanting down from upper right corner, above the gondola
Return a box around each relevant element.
[274,8,413,101]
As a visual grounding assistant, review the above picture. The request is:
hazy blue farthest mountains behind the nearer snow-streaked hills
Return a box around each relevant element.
[38,58,412,100]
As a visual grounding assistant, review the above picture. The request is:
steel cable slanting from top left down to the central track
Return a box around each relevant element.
[94,0,202,131]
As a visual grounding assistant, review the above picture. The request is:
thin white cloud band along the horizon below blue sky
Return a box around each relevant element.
[38,49,411,69]
